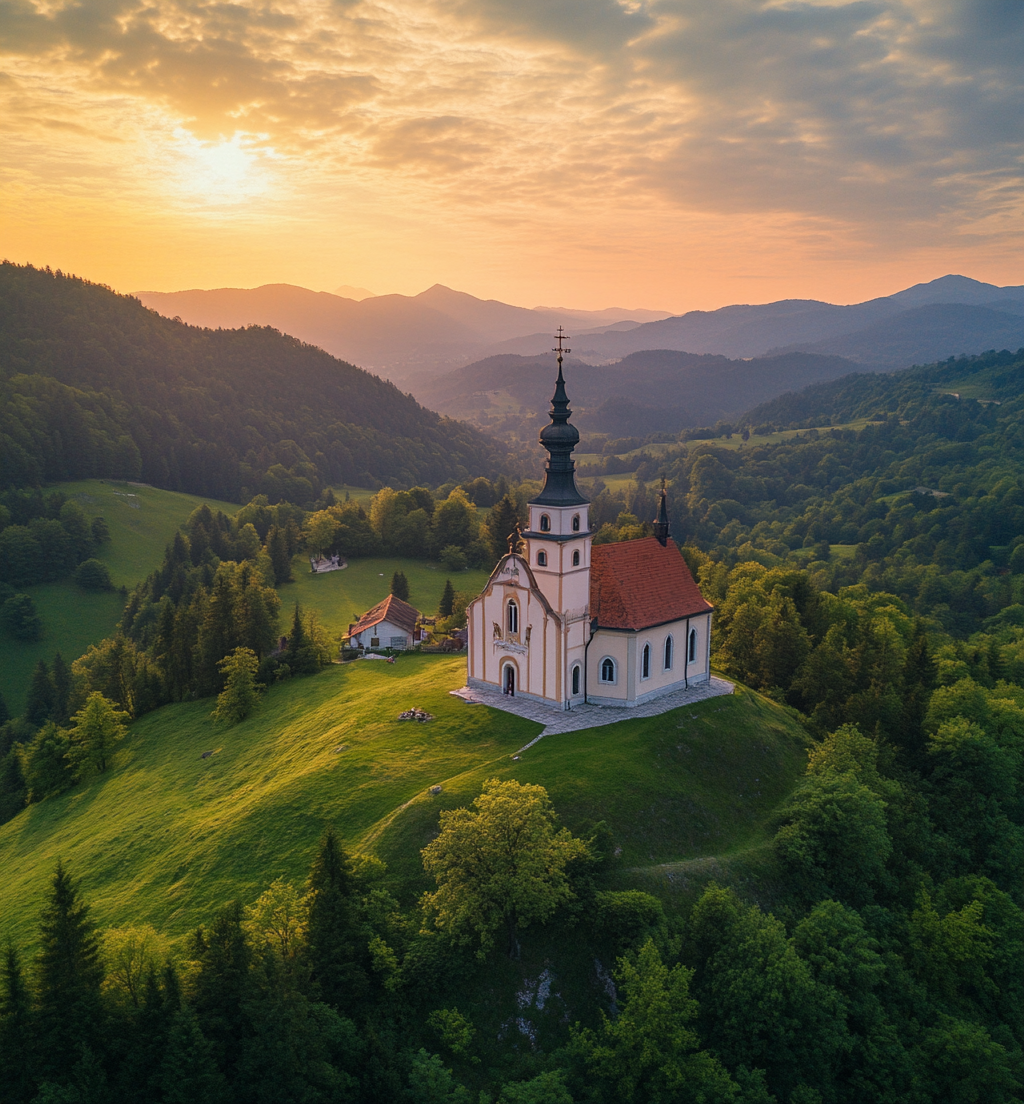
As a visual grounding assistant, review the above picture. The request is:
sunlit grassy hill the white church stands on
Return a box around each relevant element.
[0,656,804,945]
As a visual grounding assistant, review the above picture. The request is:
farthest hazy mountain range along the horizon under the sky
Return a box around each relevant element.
[138,276,1024,395]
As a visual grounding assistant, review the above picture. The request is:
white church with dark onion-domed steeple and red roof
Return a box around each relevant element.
[467,336,713,710]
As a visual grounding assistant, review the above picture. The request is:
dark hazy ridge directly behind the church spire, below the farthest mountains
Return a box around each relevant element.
[417,349,860,437]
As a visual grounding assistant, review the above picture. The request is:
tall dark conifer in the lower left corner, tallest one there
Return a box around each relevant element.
[35,860,103,1080]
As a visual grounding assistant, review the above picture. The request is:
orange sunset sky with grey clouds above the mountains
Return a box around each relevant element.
[0,0,1024,311]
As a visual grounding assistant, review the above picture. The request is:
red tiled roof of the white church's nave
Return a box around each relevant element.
[590,537,713,629]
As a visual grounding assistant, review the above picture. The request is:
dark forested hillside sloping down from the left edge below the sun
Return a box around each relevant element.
[0,262,500,505]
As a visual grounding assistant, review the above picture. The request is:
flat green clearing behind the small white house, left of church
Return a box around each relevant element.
[277,555,490,636]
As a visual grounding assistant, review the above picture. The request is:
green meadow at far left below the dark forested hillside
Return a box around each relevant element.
[0,479,238,714]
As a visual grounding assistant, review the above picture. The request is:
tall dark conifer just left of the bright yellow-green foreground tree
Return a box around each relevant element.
[306,827,366,1011]
